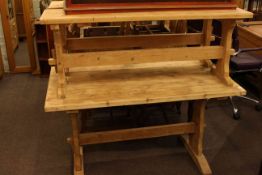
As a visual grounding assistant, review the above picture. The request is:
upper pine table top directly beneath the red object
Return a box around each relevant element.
[40,1,253,24]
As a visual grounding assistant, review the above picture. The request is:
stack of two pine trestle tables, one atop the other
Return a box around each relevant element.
[40,2,252,175]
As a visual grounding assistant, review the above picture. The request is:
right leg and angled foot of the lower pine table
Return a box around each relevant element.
[182,100,212,175]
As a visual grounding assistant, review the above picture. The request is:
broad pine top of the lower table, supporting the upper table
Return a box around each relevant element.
[45,61,245,112]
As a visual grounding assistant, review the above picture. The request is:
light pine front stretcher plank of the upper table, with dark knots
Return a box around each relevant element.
[62,46,223,67]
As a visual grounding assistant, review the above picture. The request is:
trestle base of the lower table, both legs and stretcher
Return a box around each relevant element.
[68,100,212,175]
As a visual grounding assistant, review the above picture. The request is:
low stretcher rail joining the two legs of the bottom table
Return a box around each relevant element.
[68,122,195,145]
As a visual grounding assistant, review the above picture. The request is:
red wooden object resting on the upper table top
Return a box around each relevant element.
[65,0,237,14]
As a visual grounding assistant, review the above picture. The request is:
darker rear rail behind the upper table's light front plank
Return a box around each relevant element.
[66,33,203,51]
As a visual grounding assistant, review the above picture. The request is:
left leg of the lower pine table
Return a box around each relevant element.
[69,111,84,175]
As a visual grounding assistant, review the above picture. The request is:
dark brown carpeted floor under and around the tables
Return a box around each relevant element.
[0,74,262,175]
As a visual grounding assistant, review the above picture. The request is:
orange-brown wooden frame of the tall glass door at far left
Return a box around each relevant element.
[0,0,37,73]
